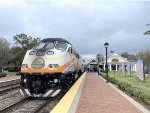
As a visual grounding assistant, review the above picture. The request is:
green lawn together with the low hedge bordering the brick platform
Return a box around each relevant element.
[106,71,150,106]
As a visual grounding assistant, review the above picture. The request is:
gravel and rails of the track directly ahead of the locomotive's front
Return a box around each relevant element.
[0,98,59,113]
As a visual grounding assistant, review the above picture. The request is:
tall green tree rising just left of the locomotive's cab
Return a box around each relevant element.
[11,34,40,66]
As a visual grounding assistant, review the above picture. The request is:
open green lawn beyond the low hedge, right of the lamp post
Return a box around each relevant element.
[109,71,150,95]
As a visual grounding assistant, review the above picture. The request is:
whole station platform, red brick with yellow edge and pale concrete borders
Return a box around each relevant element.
[50,73,150,113]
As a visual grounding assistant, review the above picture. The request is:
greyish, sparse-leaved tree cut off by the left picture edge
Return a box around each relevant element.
[0,38,13,72]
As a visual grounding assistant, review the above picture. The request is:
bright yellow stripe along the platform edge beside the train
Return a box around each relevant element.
[50,72,86,113]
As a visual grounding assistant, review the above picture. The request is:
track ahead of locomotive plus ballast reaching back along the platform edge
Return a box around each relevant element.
[0,87,70,113]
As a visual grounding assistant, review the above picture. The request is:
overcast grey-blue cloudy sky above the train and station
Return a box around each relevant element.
[0,0,150,55]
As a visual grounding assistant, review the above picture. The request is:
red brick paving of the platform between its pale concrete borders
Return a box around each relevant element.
[76,73,142,113]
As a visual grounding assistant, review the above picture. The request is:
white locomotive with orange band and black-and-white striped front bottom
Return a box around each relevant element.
[20,38,84,97]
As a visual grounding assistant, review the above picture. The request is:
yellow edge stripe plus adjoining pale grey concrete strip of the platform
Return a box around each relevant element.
[50,73,86,113]
